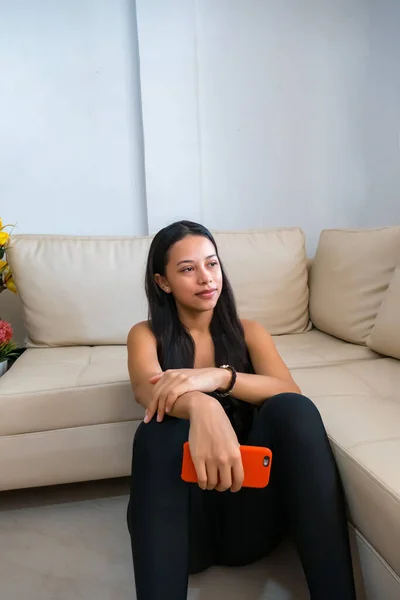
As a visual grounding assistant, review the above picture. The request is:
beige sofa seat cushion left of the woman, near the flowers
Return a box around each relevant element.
[0,346,144,435]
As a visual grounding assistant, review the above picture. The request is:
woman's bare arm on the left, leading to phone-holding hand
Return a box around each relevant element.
[127,321,213,422]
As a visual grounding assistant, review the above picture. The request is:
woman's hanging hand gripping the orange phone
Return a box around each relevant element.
[189,396,244,492]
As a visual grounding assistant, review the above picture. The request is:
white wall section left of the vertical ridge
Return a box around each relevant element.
[0,0,147,235]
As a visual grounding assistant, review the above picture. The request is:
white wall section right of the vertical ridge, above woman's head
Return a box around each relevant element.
[137,0,400,253]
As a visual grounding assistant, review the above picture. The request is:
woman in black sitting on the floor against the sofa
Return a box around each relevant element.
[128,221,355,600]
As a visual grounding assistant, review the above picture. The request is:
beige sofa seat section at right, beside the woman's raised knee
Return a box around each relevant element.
[293,358,400,573]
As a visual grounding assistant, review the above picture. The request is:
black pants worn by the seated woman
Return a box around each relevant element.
[127,393,355,600]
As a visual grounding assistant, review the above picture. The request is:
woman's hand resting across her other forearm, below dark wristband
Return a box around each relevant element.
[144,368,231,423]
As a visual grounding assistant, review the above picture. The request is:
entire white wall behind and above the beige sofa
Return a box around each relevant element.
[0,0,400,342]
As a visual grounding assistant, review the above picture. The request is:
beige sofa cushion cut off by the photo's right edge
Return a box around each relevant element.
[367,266,400,358]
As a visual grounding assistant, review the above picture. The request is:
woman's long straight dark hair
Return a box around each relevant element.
[145,221,250,373]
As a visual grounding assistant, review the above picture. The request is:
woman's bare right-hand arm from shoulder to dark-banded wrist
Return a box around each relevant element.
[227,319,301,404]
